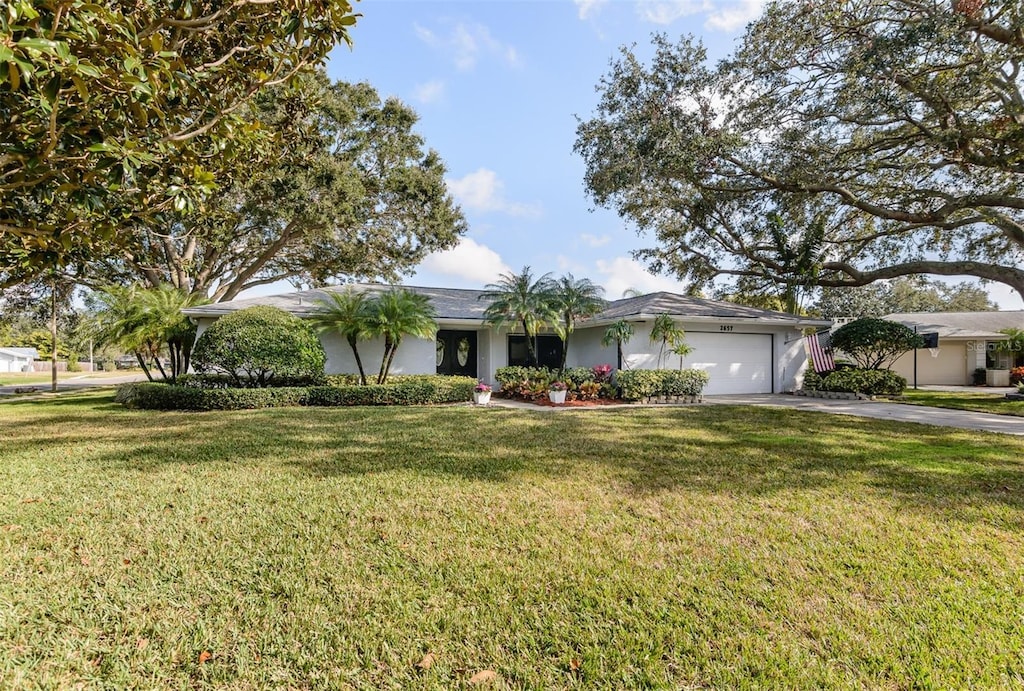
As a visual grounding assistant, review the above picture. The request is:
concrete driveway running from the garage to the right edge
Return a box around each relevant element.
[705,393,1024,436]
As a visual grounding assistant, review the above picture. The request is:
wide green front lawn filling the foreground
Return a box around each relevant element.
[0,393,1024,689]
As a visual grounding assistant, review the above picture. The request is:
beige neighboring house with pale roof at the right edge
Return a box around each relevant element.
[882,310,1024,386]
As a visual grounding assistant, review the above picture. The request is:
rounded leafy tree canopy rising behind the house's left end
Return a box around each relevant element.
[89,71,466,302]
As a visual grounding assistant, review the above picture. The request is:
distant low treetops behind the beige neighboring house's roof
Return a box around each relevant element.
[812,276,997,318]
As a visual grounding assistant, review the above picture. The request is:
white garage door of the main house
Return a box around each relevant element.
[683,331,774,395]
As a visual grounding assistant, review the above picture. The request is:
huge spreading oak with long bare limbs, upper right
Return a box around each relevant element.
[575,0,1024,295]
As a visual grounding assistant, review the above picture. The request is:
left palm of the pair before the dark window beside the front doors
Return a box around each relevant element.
[480,266,558,366]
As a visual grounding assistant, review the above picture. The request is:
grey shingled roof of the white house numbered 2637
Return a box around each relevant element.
[182,284,831,327]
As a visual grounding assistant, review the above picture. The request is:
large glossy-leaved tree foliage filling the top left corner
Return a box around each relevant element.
[0,0,356,279]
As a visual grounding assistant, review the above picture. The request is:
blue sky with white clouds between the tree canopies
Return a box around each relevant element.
[313,0,1024,309]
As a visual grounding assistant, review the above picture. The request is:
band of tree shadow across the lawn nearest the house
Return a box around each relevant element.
[0,397,1024,518]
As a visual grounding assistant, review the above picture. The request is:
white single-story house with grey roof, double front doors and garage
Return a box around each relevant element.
[183,285,831,394]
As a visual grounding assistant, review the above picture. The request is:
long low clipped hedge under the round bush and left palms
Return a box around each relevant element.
[115,375,476,411]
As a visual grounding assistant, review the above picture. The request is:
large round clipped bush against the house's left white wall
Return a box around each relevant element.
[193,306,327,388]
